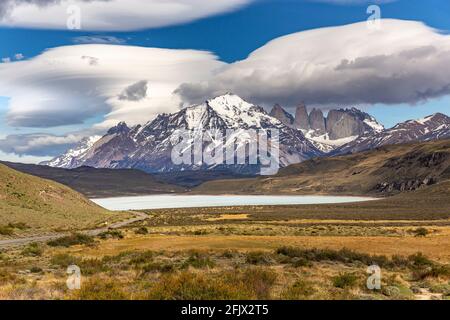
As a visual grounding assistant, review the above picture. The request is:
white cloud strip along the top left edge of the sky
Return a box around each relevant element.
[0,0,252,31]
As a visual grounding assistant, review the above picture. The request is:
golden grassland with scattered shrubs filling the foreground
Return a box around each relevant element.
[0,208,450,300]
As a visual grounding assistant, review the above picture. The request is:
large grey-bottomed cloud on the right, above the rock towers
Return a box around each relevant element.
[177,20,450,110]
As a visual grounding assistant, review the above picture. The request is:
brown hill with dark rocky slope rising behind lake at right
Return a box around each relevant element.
[194,140,450,196]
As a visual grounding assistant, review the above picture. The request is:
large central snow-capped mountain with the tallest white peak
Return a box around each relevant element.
[44,94,323,173]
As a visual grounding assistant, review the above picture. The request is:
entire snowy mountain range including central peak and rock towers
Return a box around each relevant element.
[42,94,450,174]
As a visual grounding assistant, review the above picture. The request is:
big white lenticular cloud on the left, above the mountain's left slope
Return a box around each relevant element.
[0,44,224,129]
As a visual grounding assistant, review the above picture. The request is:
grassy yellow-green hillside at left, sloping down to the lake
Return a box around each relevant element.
[0,164,121,231]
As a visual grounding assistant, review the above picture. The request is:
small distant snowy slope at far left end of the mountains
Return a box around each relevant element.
[41,136,101,168]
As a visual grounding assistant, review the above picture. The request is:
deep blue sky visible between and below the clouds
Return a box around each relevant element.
[0,0,450,162]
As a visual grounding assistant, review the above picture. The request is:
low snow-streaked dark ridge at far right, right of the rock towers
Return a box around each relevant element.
[332,113,450,155]
